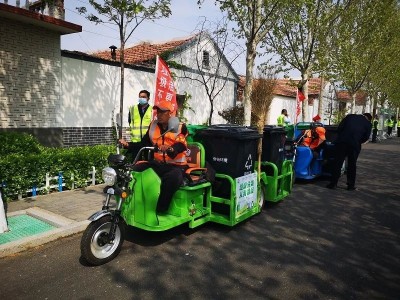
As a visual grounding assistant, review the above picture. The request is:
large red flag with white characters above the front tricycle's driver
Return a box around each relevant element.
[154,55,178,116]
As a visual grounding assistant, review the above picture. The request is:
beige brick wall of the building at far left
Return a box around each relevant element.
[0,18,61,129]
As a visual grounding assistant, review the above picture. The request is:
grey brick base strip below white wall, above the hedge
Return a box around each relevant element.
[63,127,115,147]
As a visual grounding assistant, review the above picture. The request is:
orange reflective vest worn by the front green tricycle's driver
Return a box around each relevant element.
[149,120,187,165]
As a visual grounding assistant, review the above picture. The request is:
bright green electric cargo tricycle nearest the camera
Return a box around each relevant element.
[81,122,292,265]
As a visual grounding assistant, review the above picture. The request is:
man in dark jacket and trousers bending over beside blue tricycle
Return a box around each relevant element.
[326,113,372,191]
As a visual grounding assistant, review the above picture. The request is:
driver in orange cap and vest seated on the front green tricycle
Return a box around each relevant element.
[120,100,188,213]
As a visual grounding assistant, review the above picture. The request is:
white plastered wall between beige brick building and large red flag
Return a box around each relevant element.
[57,57,154,127]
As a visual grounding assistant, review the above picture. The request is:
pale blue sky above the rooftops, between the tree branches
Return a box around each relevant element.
[61,0,250,70]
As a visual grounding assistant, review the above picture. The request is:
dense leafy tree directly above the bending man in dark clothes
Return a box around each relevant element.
[326,0,396,112]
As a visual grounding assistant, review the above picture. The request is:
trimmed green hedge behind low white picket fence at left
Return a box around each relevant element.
[0,133,115,201]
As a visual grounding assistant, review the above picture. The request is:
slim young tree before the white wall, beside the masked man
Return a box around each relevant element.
[77,0,171,137]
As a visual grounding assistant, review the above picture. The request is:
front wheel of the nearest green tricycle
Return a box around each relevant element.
[81,216,125,266]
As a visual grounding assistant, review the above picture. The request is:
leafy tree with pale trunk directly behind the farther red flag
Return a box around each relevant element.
[263,0,348,120]
